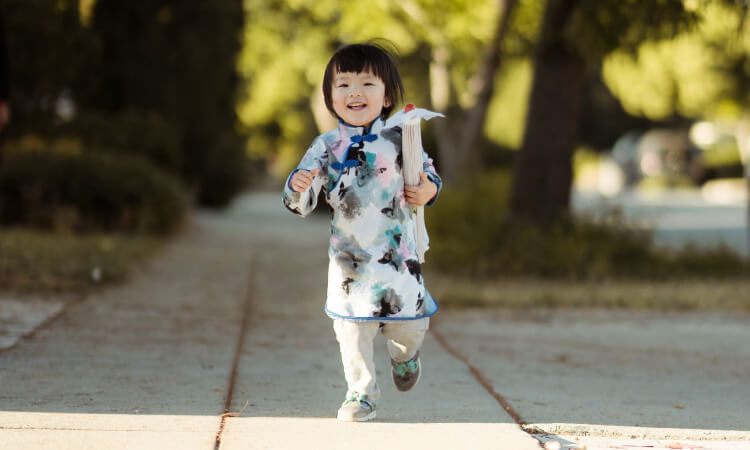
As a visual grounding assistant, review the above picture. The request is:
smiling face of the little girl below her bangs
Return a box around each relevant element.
[331,72,390,127]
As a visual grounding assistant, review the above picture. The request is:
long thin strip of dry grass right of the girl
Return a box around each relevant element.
[427,274,750,311]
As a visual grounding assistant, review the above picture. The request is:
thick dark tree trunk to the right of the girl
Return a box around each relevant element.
[511,0,586,224]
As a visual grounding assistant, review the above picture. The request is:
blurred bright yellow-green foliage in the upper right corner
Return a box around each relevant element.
[603,1,750,119]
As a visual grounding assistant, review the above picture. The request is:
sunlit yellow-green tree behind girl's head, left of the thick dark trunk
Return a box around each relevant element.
[239,0,508,180]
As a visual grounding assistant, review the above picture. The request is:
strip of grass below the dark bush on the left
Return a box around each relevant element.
[0,229,160,293]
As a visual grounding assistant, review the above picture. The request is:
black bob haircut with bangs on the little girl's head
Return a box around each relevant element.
[323,42,404,119]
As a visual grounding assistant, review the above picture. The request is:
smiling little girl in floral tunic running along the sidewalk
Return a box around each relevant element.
[283,44,442,422]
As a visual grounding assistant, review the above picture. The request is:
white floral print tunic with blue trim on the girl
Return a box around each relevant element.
[282,111,442,322]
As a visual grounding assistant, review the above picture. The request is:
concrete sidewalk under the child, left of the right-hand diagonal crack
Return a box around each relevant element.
[0,194,539,449]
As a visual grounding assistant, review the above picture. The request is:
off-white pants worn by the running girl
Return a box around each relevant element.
[333,318,430,400]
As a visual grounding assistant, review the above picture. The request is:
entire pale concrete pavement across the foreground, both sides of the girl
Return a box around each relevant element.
[0,194,750,450]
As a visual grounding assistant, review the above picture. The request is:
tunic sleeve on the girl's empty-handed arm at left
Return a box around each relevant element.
[281,137,328,217]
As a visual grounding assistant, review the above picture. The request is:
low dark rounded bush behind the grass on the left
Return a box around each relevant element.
[0,151,187,233]
